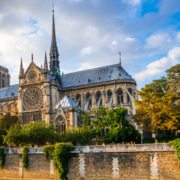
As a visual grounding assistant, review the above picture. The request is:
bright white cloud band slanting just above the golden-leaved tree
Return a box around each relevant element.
[134,47,180,82]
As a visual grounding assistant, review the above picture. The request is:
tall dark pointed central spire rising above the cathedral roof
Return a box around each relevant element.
[49,8,59,76]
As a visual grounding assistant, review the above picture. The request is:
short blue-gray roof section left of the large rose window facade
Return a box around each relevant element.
[0,84,19,99]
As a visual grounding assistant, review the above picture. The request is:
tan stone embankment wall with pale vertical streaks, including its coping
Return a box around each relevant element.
[0,144,180,180]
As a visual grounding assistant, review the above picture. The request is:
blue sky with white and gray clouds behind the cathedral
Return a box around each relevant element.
[0,0,180,89]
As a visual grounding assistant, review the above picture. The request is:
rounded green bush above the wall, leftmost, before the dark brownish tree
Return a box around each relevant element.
[3,123,24,147]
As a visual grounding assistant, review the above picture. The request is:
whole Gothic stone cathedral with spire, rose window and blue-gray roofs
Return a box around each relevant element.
[0,10,137,133]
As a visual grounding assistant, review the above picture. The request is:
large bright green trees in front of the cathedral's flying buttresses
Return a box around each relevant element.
[82,107,140,143]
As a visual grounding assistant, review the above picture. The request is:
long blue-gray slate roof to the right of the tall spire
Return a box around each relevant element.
[62,64,133,88]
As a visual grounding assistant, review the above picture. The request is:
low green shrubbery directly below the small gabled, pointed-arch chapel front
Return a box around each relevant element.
[58,127,94,145]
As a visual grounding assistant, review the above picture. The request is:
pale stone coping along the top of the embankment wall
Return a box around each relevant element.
[4,143,175,154]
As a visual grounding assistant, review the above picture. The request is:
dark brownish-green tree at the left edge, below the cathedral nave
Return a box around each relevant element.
[0,113,19,135]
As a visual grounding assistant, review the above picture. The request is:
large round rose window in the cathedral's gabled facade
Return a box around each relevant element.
[23,87,43,110]
